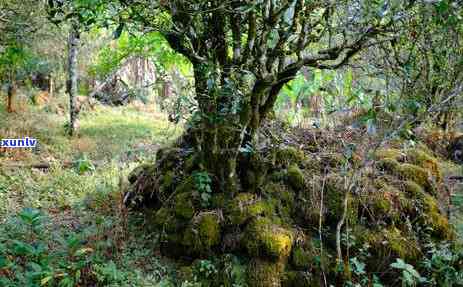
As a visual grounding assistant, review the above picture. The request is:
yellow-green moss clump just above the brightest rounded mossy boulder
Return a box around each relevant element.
[225,193,274,225]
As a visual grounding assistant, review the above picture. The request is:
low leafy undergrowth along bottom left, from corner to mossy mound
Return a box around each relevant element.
[0,208,170,287]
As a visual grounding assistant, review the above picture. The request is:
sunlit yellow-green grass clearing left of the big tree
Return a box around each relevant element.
[0,97,182,216]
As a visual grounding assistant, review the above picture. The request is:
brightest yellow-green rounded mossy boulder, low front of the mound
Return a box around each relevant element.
[244,217,293,260]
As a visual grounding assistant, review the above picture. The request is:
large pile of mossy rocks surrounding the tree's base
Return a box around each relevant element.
[125,137,454,287]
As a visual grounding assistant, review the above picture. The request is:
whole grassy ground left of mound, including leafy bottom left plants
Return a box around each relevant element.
[0,98,182,286]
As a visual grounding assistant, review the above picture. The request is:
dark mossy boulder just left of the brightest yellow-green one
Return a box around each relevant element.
[183,212,221,255]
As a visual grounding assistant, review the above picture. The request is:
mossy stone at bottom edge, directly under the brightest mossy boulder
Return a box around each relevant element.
[247,259,283,287]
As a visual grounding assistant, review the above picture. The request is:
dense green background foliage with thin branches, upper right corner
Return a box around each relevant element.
[357,0,463,133]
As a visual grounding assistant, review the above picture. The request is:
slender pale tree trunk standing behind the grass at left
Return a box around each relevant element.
[67,22,79,136]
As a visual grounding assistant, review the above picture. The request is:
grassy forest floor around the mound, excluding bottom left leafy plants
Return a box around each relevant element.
[0,95,463,286]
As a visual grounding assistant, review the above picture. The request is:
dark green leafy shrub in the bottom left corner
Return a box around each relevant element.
[0,208,94,287]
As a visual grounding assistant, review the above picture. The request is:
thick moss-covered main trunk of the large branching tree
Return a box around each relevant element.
[185,64,283,194]
